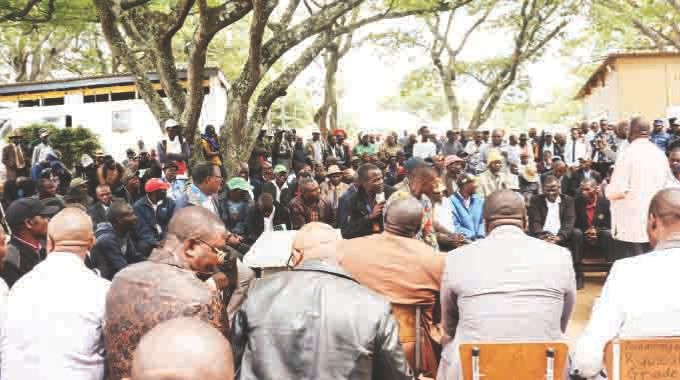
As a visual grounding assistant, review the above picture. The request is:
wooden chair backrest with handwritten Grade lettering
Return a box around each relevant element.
[604,337,680,380]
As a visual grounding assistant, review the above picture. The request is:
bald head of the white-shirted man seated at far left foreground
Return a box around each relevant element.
[47,208,94,258]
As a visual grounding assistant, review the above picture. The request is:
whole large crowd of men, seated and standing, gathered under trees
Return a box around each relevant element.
[0,117,680,380]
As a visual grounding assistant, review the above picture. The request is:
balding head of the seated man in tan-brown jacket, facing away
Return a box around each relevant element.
[385,195,423,238]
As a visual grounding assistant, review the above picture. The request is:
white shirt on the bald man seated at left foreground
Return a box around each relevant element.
[2,252,110,380]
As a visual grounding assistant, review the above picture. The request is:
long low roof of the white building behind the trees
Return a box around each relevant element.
[0,67,219,96]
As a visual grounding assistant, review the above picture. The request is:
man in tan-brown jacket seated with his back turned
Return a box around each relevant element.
[338,197,445,378]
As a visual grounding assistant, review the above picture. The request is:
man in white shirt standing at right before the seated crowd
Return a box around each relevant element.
[606,117,673,258]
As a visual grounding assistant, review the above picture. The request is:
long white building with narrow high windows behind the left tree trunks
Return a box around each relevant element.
[0,68,227,160]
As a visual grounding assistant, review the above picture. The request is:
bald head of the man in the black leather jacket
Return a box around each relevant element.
[293,222,341,265]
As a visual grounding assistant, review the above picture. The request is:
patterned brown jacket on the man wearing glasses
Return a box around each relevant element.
[104,249,229,380]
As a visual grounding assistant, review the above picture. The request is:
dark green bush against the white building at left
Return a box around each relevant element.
[8,124,101,168]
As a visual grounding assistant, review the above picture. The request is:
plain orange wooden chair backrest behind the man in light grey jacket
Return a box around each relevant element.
[459,342,569,380]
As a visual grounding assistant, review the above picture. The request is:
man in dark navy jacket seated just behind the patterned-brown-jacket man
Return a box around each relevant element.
[90,199,142,280]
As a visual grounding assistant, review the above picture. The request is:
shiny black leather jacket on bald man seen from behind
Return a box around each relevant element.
[231,261,413,380]
